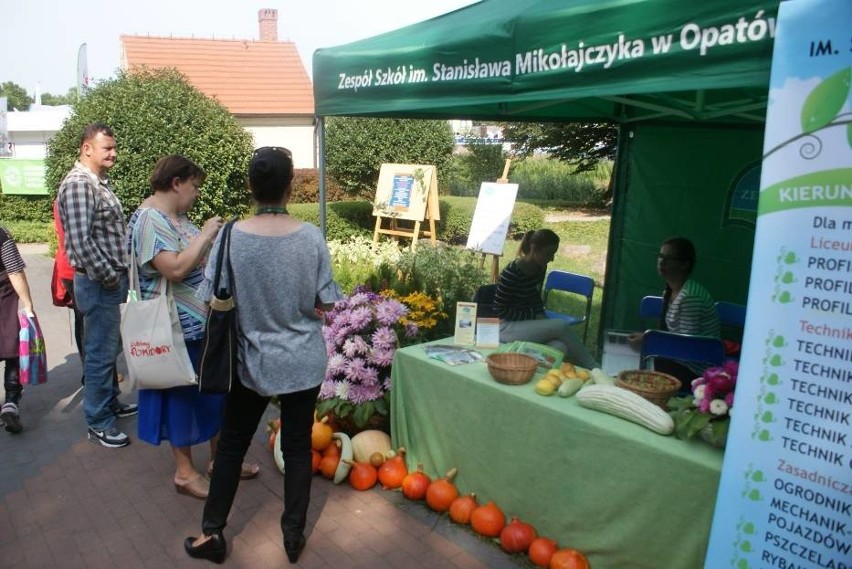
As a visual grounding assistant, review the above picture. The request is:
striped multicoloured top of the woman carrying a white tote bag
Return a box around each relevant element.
[127,207,207,341]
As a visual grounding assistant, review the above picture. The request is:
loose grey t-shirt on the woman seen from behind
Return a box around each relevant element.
[199,223,341,396]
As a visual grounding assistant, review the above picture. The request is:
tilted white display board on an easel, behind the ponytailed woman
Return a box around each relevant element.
[467,182,518,255]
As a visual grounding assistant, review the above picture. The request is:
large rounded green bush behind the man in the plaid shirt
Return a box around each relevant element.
[46,69,252,222]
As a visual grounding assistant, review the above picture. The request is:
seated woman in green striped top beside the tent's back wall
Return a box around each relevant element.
[630,237,721,389]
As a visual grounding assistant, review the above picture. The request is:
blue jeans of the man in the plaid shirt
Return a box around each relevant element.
[74,273,127,431]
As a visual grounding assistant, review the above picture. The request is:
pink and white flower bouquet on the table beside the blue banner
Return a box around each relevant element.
[668,360,739,447]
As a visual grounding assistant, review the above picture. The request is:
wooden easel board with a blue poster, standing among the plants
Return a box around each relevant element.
[373,164,441,250]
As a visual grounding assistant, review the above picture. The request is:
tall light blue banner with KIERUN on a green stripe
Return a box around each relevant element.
[705,0,852,569]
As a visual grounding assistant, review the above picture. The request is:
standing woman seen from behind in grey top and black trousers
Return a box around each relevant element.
[184,147,341,563]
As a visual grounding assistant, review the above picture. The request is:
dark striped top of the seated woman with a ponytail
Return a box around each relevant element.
[494,259,546,322]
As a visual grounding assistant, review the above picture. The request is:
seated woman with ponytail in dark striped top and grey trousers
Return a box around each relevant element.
[494,229,600,369]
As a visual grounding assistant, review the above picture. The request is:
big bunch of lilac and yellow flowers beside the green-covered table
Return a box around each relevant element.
[317,287,446,429]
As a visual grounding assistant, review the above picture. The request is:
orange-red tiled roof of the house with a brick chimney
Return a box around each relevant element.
[121,35,314,115]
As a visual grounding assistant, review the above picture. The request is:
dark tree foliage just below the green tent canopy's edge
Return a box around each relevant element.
[503,123,618,172]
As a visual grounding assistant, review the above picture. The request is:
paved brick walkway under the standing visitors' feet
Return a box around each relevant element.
[0,246,531,569]
